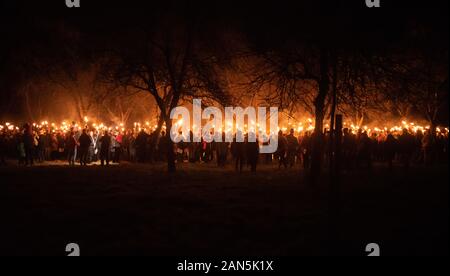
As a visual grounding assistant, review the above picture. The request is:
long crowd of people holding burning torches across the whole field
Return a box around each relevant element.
[0,123,448,171]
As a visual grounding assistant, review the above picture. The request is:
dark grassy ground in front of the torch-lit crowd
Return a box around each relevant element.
[0,161,449,256]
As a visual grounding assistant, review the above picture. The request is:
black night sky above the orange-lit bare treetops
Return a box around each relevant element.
[0,0,449,119]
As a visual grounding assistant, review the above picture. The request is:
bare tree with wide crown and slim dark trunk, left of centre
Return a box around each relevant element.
[103,15,229,172]
